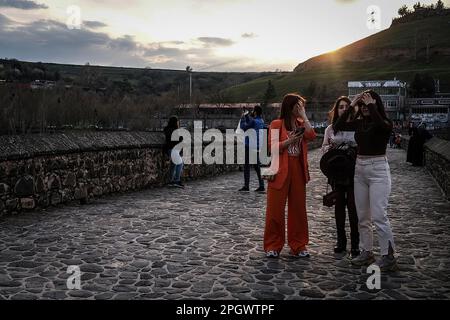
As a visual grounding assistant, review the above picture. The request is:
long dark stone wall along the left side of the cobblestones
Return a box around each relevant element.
[0,131,322,215]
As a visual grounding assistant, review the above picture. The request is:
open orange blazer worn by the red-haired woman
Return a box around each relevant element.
[268,118,316,190]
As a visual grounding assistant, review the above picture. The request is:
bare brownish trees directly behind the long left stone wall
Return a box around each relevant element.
[0,84,182,134]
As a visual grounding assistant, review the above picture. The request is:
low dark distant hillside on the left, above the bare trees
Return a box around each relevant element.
[0,59,273,99]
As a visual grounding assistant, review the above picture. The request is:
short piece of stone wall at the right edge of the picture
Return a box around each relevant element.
[424,137,450,200]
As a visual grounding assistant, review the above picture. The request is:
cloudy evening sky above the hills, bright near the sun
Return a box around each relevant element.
[0,0,450,72]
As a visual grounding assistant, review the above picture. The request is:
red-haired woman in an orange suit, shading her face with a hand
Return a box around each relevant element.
[264,93,316,258]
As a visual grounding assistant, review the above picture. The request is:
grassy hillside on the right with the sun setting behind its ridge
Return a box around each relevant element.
[226,15,450,101]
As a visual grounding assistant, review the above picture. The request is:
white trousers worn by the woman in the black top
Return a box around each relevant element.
[354,156,395,255]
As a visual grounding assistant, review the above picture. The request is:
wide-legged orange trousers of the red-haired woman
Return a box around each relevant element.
[264,156,309,254]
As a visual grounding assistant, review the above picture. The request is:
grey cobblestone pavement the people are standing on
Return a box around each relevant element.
[0,150,450,299]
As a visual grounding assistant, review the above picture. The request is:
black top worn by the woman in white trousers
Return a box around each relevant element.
[334,104,392,156]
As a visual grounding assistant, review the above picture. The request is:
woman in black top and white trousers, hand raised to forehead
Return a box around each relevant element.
[335,90,397,271]
